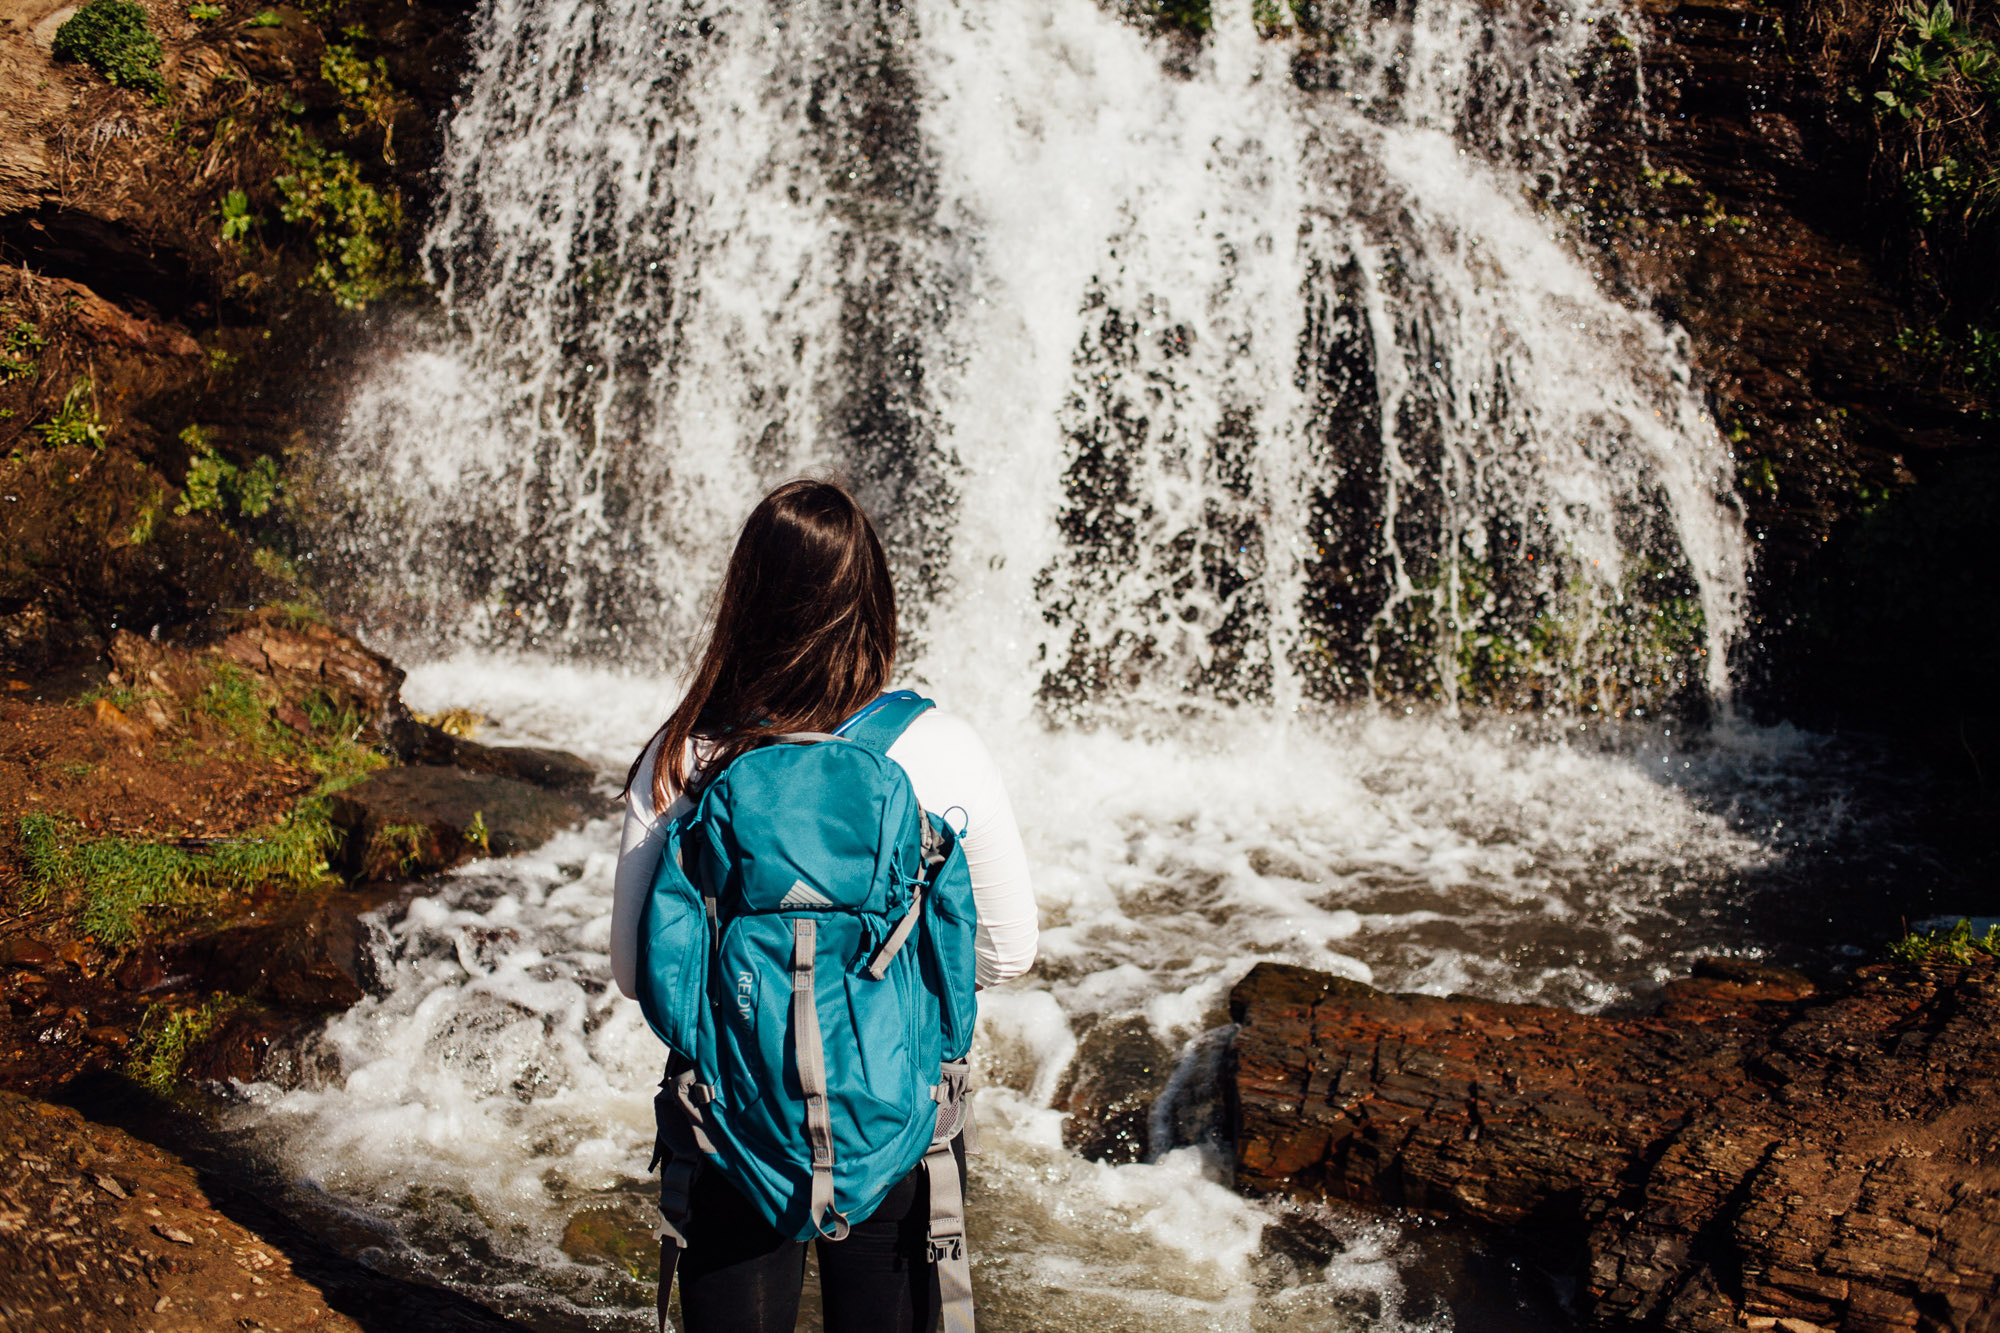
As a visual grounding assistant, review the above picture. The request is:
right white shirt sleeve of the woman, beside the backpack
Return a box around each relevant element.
[888,711,1042,987]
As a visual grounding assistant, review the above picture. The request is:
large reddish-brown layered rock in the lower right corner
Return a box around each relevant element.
[1230,959,2000,1333]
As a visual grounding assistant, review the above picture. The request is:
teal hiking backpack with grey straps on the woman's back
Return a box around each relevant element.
[638,691,978,1333]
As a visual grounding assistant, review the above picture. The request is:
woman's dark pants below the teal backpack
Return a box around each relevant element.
[676,1139,966,1333]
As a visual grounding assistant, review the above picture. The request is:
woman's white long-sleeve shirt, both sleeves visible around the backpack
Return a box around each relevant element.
[612,709,1040,995]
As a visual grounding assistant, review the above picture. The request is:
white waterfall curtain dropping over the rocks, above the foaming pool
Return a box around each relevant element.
[328,0,1746,719]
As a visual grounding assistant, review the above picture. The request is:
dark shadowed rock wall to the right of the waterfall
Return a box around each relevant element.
[1588,0,2000,740]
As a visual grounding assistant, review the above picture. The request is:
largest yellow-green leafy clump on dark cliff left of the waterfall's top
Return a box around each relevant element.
[274,124,402,310]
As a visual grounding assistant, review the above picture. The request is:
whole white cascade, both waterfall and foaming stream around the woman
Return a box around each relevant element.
[242,0,1818,1329]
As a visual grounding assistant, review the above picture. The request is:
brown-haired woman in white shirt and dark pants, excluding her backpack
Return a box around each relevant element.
[612,480,1038,1333]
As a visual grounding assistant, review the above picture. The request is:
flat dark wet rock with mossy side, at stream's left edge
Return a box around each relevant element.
[332,765,588,881]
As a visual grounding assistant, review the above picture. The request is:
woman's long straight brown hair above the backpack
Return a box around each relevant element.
[626,480,896,813]
